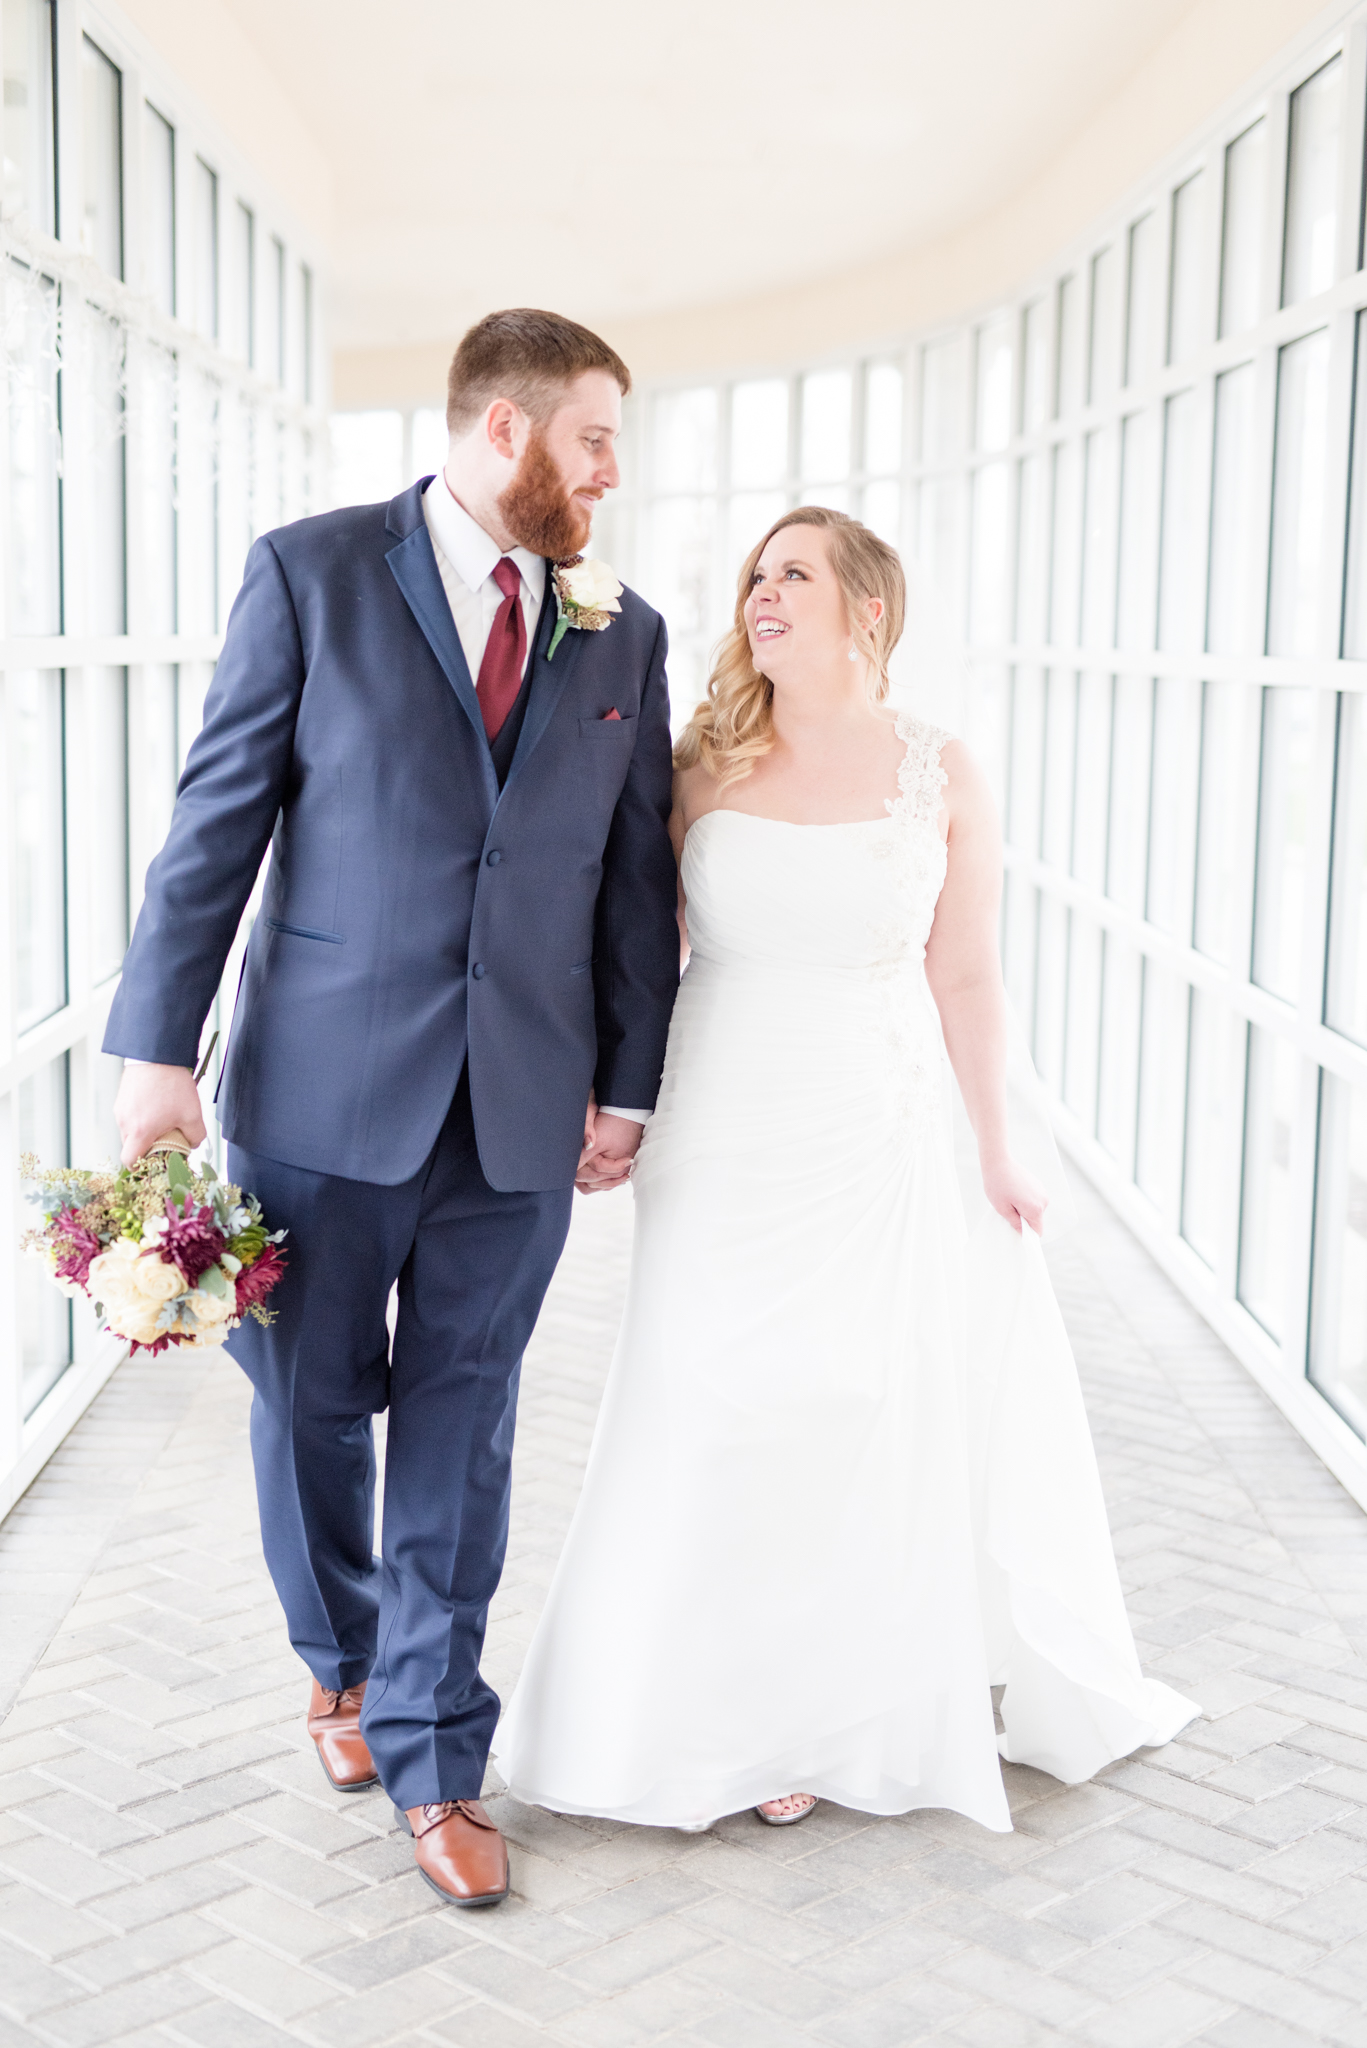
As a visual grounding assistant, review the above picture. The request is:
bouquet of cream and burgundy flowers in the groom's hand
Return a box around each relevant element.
[18,1151,285,1352]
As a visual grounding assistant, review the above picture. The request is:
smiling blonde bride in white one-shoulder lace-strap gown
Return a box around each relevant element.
[494,506,1197,1829]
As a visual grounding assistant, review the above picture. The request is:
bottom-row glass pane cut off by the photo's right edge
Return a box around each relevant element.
[1310,1073,1367,1436]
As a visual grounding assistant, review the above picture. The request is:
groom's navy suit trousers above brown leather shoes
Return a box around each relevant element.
[227,1071,574,1806]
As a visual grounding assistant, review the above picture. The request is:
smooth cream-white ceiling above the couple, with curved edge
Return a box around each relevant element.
[227,0,1193,348]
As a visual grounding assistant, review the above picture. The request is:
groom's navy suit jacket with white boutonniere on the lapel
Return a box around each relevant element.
[105,483,678,1190]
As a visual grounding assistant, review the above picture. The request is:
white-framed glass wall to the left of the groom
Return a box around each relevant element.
[0,0,326,1513]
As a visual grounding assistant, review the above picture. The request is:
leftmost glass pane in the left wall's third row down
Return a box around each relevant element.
[4,668,66,1032]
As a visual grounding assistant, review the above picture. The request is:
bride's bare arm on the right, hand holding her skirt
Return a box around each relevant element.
[926,739,1047,1231]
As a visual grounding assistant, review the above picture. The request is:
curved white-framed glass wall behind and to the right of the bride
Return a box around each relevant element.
[635,10,1367,1501]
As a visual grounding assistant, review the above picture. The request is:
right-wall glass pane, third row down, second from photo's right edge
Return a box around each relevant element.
[1252,688,1314,1004]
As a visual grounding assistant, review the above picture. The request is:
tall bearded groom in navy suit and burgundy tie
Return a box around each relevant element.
[105,309,678,1905]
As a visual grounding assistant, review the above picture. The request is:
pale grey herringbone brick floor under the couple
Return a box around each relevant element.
[0,1192,1367,2048]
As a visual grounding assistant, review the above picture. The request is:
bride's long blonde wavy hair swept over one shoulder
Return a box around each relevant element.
[674,506,906,788]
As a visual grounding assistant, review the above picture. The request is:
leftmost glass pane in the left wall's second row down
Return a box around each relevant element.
[4,264,61,633]
